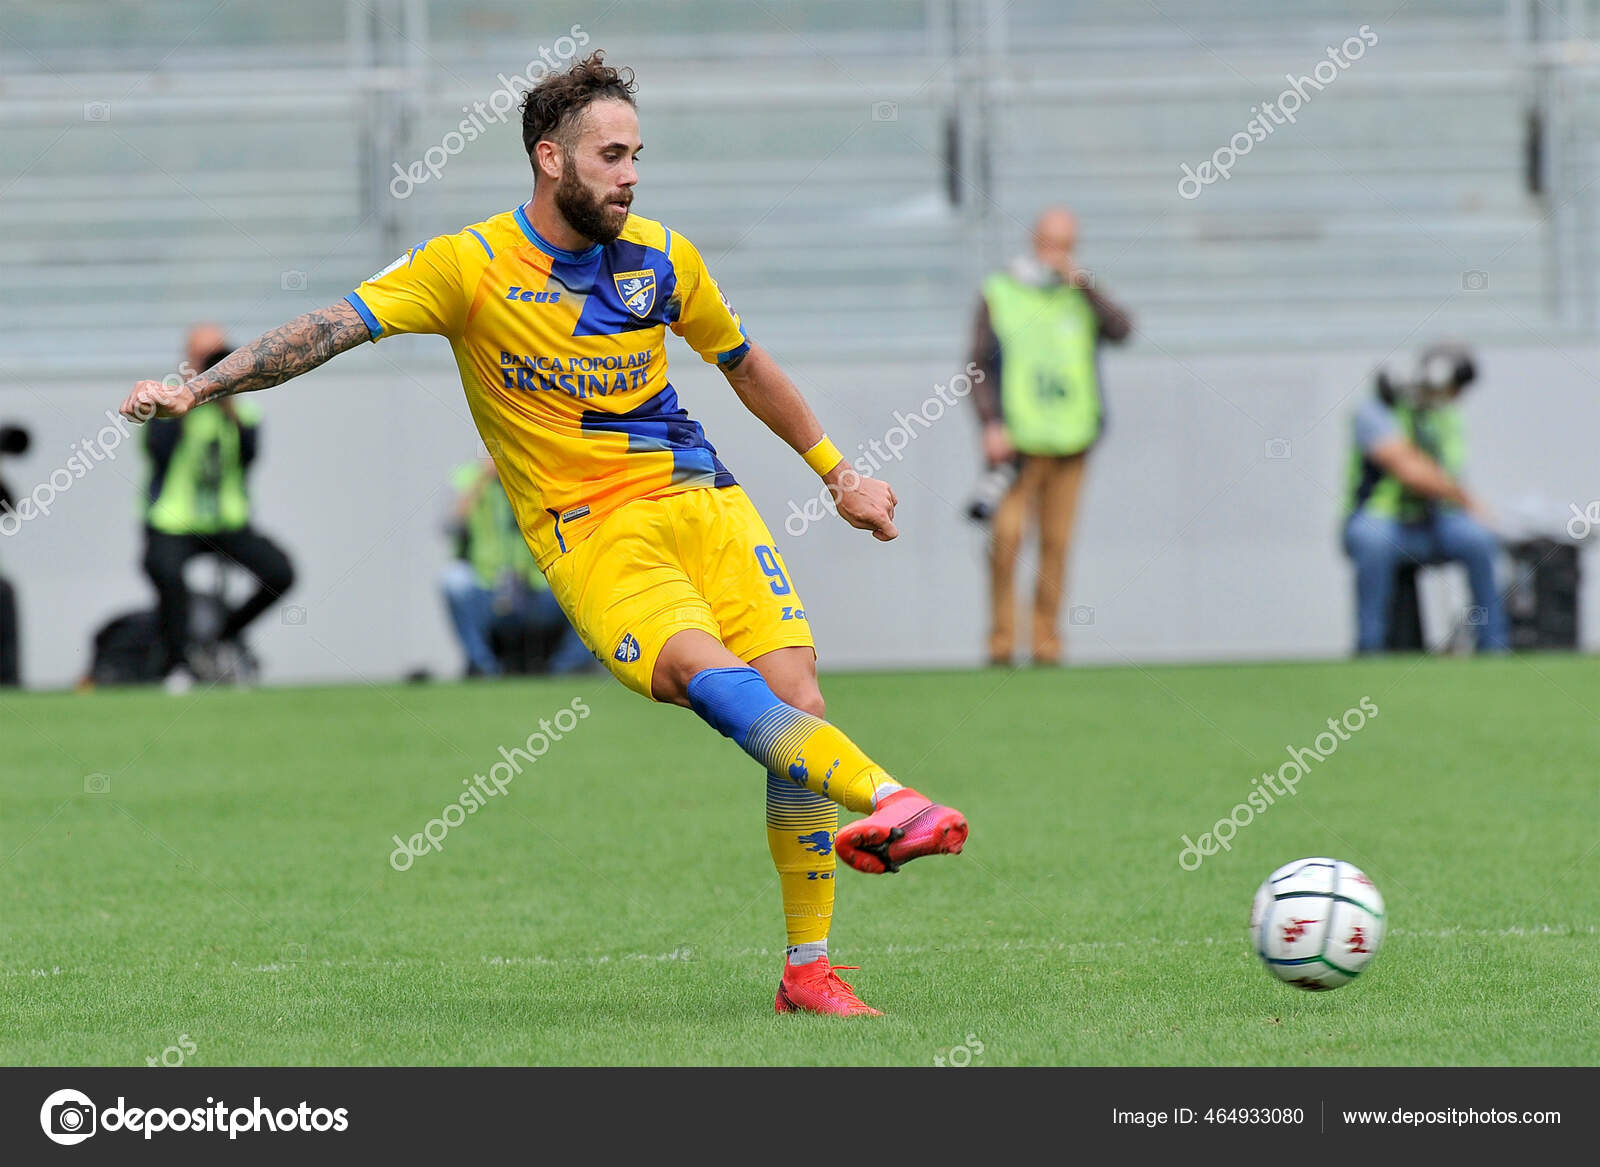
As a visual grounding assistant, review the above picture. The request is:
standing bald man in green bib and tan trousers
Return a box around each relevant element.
[971,207,1133,664]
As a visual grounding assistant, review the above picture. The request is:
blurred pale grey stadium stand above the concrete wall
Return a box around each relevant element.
[0,0,1580,368]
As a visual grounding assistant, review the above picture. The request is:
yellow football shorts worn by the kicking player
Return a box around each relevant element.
[546,487,816,696]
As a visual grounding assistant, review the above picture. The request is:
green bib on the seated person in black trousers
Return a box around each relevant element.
[144,402,258,535]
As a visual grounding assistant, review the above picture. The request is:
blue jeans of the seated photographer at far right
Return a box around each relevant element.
[1344,509,1510,653]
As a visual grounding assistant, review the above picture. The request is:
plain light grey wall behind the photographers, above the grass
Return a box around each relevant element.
[0,338,1600,687]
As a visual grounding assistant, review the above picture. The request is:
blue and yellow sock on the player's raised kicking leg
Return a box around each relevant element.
[688,668,899,815]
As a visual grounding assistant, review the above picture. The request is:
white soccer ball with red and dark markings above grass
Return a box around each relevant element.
[1250,860,1384,991]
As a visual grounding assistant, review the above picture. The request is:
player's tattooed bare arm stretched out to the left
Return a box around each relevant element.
[122,299,371,421]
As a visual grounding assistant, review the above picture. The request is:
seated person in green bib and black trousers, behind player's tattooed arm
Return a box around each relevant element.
[144,325,294,692]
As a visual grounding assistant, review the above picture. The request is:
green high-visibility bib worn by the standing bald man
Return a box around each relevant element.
[984,272,1101,455]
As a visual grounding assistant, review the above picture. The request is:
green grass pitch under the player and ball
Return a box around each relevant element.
[0,656,1600,1066]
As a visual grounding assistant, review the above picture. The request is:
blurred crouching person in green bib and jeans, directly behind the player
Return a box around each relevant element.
[440,458,595,677]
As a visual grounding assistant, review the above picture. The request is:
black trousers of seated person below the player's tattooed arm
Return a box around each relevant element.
[144,527,294,669]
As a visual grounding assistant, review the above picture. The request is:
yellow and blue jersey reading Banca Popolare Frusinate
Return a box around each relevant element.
[347,207,750,570]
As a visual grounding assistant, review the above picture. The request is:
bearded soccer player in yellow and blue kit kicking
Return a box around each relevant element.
[122,53,966,1015]
